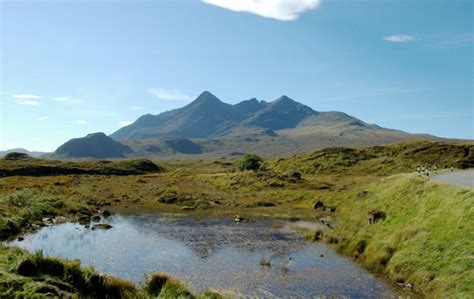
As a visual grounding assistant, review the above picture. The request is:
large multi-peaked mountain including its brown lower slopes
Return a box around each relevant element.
[110,91,442,156]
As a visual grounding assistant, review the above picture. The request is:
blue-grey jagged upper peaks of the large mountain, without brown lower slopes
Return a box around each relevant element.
[110,91,366,140]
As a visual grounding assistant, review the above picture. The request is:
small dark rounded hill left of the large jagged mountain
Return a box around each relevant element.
[52,133,132,159]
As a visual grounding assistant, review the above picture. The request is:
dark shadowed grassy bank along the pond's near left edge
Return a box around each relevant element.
[0,245,222,299]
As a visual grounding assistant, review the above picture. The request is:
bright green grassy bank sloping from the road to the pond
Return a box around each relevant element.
[308,175,474,298]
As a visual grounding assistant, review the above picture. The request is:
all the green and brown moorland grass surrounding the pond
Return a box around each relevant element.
[0,142,474,298]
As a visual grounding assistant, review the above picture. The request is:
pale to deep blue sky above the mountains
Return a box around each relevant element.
[0,0,474,151]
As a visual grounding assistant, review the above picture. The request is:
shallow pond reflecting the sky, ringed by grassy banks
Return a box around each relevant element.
[10,213,396,298]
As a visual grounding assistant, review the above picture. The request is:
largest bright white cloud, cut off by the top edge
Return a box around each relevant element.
[203,0,321,21]
